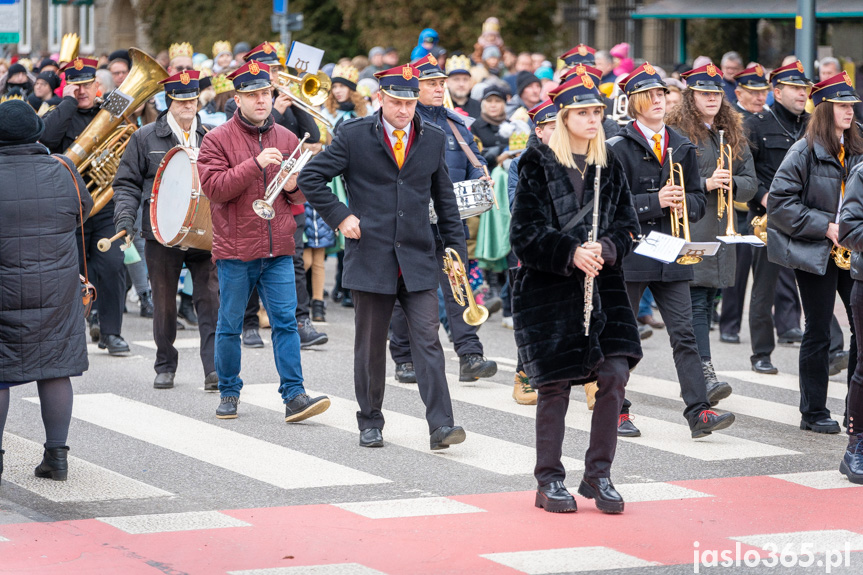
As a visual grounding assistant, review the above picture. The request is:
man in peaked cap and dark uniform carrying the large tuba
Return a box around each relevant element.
[40,58,129,355]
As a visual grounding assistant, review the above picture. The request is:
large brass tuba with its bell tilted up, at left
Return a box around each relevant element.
[65,48,168,216]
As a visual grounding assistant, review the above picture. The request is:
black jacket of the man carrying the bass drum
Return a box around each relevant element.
[114,110,209,240]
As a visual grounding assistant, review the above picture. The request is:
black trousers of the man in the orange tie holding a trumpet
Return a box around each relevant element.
[352,278,453,433]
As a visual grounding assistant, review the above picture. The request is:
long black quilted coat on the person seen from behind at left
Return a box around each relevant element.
[0,144,93,384]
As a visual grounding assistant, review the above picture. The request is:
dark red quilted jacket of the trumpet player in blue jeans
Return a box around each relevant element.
[198,114,305,261]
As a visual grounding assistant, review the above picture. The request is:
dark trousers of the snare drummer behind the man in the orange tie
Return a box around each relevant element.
[390,241,483,363]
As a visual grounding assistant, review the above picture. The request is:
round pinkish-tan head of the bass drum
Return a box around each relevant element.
[155,148,195,242]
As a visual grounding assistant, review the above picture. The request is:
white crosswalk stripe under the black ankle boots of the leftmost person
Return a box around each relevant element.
[3,434,173,503]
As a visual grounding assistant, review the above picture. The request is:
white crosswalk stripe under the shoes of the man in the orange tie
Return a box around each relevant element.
[242,384,584,475]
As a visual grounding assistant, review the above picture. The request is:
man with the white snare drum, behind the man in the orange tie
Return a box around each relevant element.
[390,54,497,383]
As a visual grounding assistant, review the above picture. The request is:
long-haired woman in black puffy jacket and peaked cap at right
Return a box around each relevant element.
[767,72,863,433]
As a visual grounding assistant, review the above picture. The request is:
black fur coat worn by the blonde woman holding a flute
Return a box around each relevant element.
[510,144,642,386]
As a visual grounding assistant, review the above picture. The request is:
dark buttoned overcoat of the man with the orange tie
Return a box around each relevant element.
[298,112,467,294]
